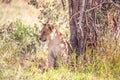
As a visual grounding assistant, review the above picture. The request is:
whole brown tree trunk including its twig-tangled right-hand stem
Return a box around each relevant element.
[68,0,97,56]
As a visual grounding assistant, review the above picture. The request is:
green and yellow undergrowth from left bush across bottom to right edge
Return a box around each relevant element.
[0,20,120,80]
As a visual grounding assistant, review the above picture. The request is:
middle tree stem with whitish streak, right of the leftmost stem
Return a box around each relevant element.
[77,0,86,55]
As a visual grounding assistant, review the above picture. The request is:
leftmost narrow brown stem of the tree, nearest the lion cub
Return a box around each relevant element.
[68,0,78,50]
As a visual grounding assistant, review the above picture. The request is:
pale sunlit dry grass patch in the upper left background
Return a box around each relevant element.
[0,0,40,25]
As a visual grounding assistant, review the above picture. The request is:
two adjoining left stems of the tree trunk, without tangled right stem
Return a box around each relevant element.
[68,0,86,56]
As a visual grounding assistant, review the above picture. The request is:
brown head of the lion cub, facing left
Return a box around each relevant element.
[39,24,53,42]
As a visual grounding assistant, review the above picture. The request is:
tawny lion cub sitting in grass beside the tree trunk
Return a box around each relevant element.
[39,24,71,68]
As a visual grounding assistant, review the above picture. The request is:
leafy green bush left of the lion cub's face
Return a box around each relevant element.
[1,20,40,53]
